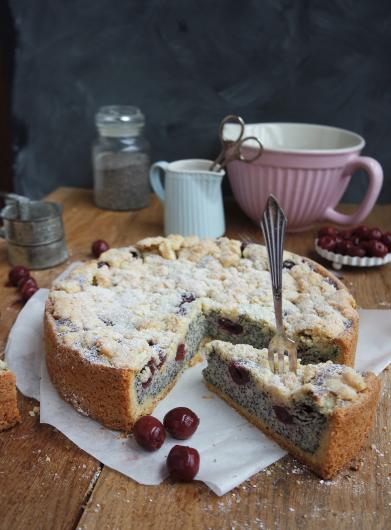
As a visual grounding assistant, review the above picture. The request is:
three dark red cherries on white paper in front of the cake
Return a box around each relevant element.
[133,407,200,482]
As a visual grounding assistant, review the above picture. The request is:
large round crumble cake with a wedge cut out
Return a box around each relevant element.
[45,236,358,430]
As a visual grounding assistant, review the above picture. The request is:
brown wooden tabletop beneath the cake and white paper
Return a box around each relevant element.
[0,188,391,530]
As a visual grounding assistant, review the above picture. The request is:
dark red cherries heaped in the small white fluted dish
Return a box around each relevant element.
[317,226,391,258]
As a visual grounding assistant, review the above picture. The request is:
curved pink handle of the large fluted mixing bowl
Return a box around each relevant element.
[324,156,383,225]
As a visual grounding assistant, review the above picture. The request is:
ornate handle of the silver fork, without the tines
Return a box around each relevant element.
[261,195,287,334]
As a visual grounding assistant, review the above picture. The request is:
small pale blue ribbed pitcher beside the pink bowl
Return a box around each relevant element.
[149,159,225,238]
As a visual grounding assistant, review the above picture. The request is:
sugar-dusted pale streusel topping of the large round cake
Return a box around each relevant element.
[49,235,355,369]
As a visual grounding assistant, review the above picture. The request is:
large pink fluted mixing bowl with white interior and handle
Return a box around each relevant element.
[224,123,383,231]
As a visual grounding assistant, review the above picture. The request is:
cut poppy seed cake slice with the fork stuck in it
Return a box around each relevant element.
[203,341,380,479]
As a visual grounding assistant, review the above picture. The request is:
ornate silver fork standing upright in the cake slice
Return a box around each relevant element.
[261,195,297,373]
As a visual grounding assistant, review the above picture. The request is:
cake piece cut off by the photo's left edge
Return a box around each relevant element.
[0,360,20,431]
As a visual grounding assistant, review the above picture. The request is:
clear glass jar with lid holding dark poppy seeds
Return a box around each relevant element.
[93,105,150,210]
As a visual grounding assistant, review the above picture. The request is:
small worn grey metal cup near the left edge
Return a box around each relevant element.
[0,193,68,269]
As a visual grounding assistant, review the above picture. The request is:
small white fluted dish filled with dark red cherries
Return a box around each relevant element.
[315,226,391,270]
